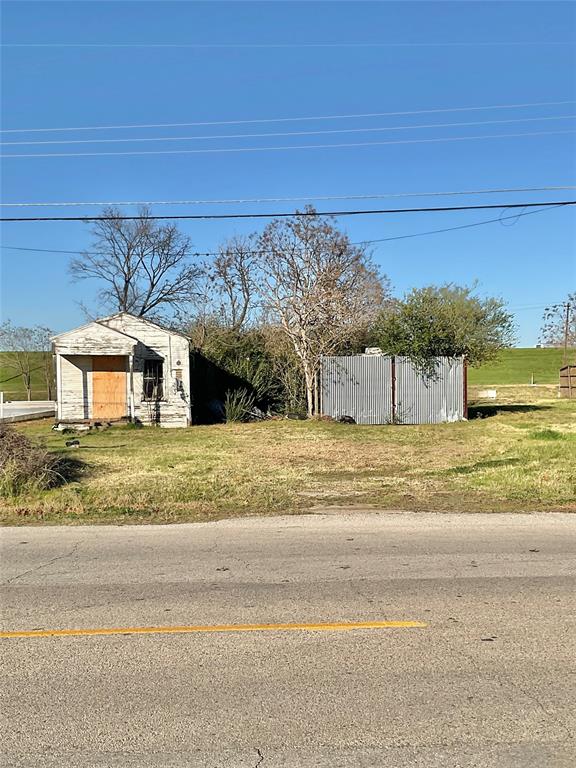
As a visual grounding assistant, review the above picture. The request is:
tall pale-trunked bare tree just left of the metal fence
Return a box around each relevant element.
[259,207,388,416]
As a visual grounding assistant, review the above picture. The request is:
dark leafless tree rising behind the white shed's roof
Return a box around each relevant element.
[70,208,201,316]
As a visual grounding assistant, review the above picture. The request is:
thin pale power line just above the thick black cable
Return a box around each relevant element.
[0,185,576,208]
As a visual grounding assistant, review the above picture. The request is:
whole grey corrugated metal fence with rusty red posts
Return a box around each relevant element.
[321,355,466,424]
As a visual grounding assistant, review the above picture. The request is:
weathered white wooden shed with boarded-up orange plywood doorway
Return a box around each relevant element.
[52,312,191,427]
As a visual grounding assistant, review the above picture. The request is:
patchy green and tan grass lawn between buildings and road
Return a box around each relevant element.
[0,387,576,524]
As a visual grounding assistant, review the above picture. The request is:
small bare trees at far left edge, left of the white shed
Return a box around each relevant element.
[0,320,54,400]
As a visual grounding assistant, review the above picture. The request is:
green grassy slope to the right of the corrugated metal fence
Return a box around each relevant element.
[468,347,576,385]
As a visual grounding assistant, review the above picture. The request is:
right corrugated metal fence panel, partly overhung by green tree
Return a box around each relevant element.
[396,357,465,424]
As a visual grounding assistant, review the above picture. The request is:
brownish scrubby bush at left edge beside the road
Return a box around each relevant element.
[0,424,81,499]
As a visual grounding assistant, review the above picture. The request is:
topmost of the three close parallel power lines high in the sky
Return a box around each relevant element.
[0,99,576,133]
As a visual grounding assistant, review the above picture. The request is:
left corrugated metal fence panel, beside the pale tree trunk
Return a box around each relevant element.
[321,355,392,424]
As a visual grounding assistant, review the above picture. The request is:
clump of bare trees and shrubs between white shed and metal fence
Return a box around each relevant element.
[186,206,389,416]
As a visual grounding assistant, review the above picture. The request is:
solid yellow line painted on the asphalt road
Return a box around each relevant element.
[0,621,427,638]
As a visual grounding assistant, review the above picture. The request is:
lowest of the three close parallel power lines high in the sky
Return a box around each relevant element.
[0,130,575,158]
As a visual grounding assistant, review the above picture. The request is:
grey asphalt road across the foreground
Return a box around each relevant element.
[0,513,576,768]
